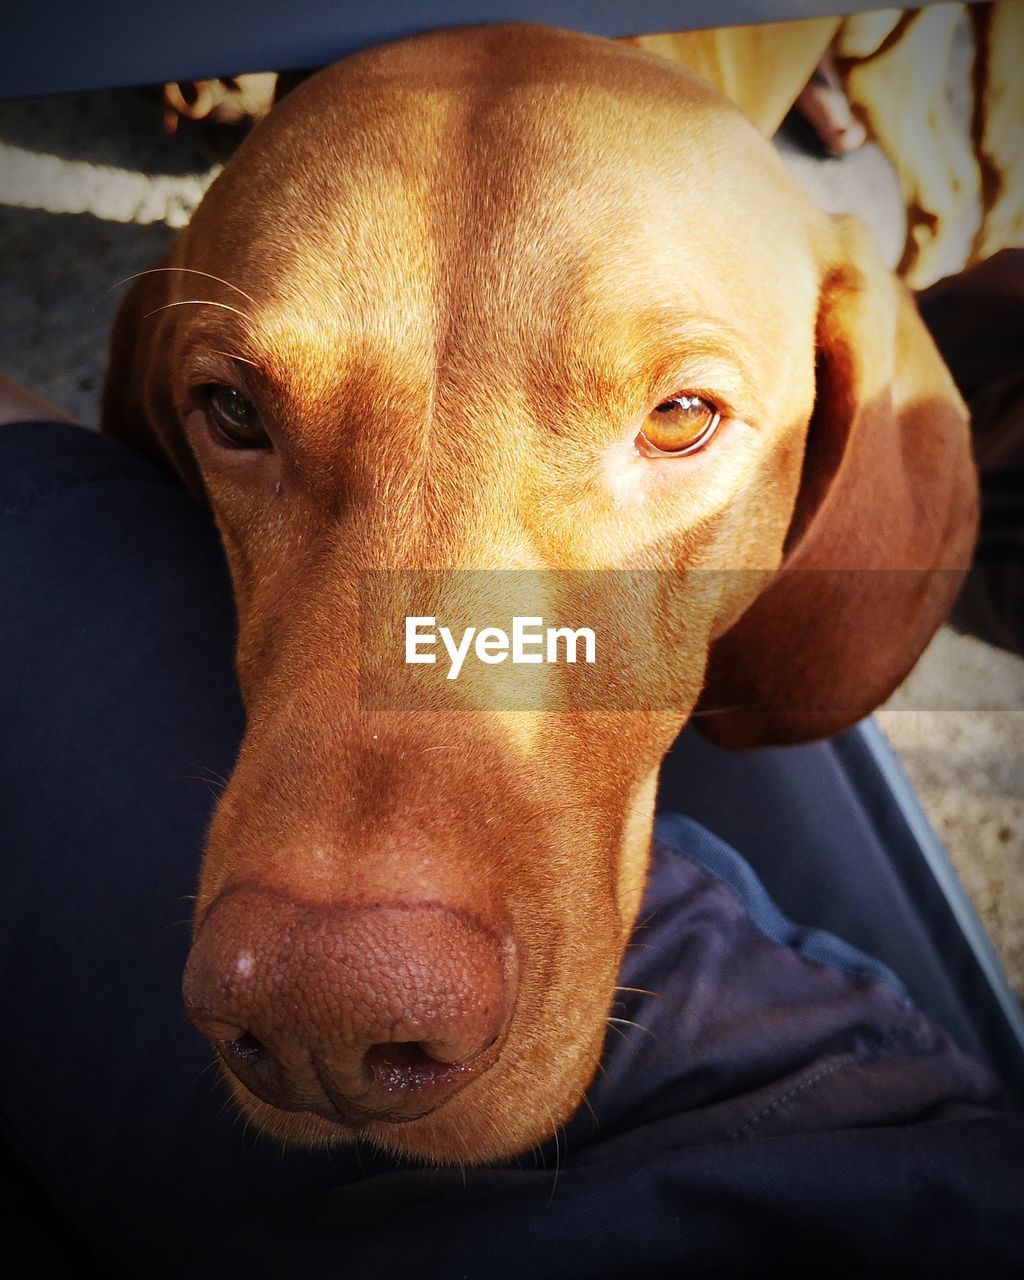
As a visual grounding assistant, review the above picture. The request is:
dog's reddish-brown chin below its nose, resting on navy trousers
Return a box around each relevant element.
[221,1036,602,1166]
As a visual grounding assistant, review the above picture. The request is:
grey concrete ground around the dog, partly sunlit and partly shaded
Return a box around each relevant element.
[0,72,1024,996]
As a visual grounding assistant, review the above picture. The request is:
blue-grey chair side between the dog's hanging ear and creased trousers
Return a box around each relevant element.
[659,727,1024,1106]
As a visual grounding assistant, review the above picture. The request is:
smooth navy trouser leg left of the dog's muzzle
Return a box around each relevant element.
[0,422,348,1274]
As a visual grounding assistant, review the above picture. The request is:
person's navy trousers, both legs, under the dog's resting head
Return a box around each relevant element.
[0,414,1024,1277]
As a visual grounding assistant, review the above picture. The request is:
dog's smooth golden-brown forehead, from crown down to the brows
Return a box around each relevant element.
[174,26,813,414]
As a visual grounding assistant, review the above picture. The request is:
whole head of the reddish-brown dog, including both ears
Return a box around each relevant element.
[105,27,974,1161]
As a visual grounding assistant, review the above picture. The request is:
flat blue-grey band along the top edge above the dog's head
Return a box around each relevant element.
[0,0,921,97]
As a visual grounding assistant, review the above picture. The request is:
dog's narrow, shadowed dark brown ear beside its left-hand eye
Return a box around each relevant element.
[100,259,204,497]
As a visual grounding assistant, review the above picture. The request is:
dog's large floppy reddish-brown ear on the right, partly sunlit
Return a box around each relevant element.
[696,219,978,748]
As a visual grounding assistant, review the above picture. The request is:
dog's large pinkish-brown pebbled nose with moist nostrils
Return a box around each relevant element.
[183,886,516,1126]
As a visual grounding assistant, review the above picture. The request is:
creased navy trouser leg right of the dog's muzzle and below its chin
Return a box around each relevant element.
[184,819,1024,1277]
